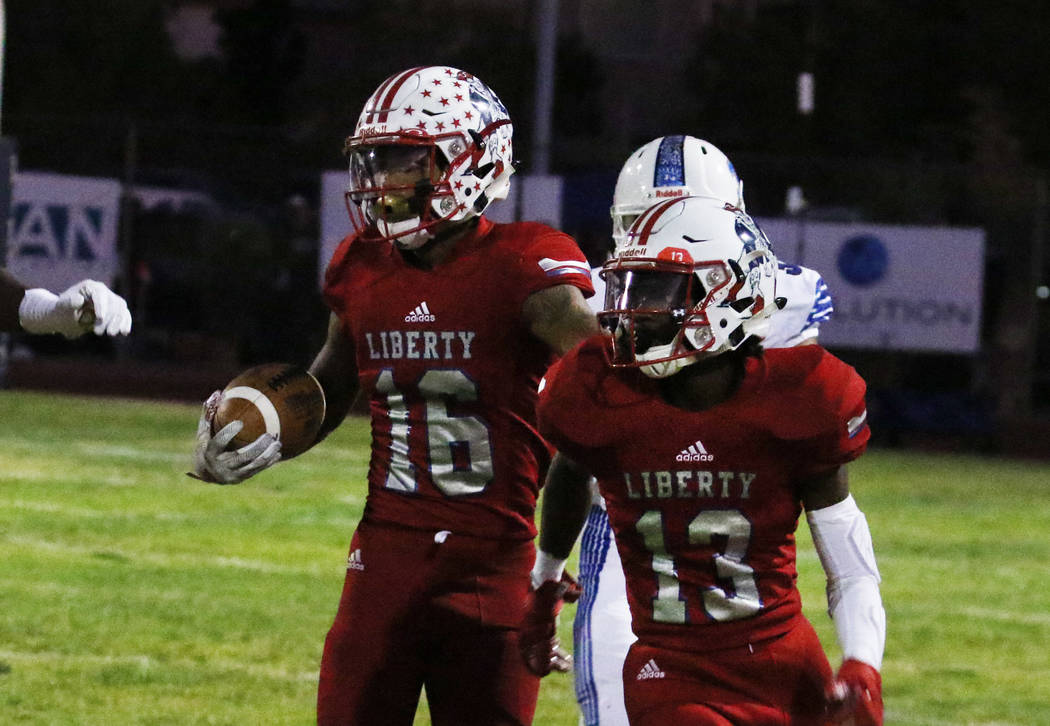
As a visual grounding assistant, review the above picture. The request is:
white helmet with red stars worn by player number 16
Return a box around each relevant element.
[344,65,513,249]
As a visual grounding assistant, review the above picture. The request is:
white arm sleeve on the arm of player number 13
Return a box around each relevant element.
[805,495,886,670]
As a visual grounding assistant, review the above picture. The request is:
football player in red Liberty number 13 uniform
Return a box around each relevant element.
[522,198,885,726]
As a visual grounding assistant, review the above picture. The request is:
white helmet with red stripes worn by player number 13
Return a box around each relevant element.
[599,196,780,378]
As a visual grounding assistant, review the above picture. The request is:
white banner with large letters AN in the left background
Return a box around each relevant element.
[7,171,121,292]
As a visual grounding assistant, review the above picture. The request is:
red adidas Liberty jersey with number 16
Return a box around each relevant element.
[324,217,593,539]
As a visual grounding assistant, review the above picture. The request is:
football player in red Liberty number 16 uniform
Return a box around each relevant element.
[196,66,597,726]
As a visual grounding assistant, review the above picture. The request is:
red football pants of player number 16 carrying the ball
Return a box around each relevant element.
[317,522,540,726]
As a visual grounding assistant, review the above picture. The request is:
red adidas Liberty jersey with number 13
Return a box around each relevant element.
[539,338,869,651]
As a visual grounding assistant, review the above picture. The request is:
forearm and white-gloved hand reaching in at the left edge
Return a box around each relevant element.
[0,270,131,338]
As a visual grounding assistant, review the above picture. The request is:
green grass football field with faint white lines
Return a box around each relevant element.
[0,392,1050,726]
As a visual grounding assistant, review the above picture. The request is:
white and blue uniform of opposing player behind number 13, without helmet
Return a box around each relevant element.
[572,258,832,726]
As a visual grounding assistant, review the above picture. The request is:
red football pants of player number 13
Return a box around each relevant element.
[624,617,832,726]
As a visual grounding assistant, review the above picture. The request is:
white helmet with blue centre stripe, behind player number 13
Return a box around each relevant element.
[610,136,744,247]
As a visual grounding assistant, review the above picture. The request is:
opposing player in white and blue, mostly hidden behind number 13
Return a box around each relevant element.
[533,136,832,726]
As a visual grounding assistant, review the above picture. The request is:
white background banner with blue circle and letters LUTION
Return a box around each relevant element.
[759,219,985,353]
